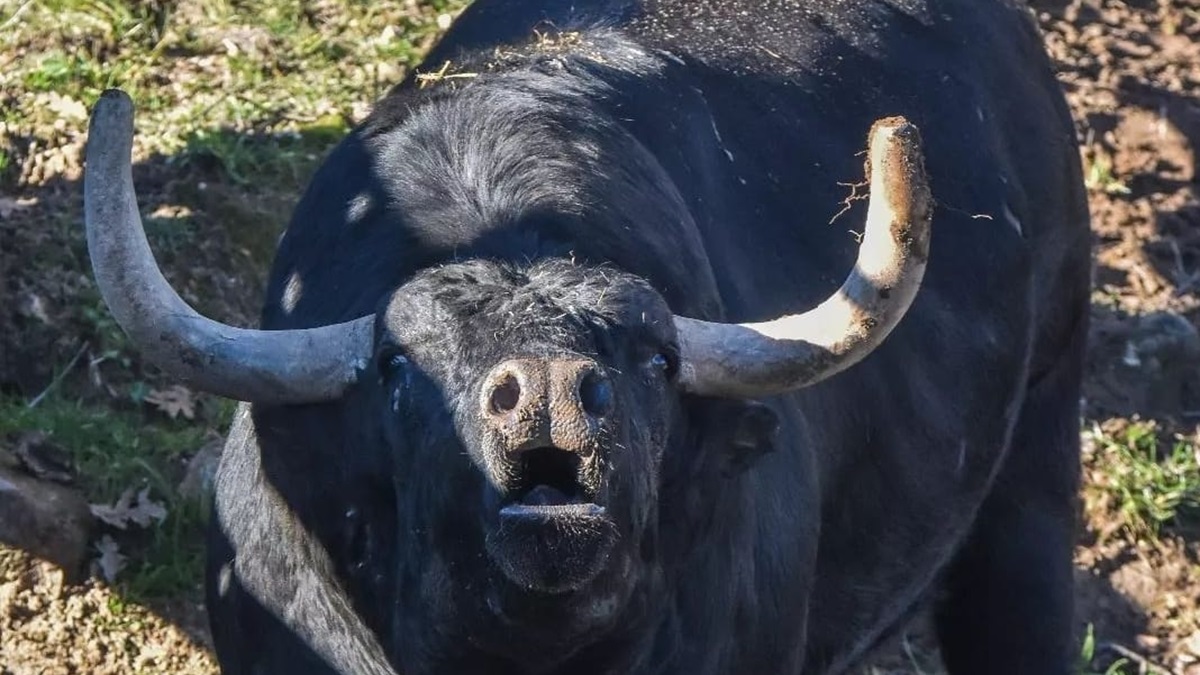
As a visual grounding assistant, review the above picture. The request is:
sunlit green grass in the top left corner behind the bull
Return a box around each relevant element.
[0,0,456,157]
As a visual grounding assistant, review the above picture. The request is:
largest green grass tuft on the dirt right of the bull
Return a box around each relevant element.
[1086,422,1200,537]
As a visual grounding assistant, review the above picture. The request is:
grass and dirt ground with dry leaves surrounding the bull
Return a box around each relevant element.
[0,0,1200,675]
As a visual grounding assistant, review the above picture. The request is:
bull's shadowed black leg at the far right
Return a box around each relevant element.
[937,306,1086,675]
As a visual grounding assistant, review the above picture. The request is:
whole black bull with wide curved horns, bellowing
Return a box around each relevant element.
[79,0,1088,675]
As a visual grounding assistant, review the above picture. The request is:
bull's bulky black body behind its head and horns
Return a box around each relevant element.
[210,0,1088,675]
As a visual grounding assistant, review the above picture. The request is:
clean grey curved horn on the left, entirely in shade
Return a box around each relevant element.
[84,89,374,404]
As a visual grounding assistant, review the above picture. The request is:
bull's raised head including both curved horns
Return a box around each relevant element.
[85,85,932,653]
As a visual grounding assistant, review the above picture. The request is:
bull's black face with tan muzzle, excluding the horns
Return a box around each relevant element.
[373,257,678,595]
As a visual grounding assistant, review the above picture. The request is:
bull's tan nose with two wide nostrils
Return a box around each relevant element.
[480,358,616,453]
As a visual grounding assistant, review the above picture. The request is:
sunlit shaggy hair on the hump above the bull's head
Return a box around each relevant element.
[368,40,653,229]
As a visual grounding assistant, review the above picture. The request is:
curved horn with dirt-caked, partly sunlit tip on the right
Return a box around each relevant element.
[674,118,934,398]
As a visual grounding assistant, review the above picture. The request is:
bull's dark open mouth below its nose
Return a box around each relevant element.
[503,447,595,513]
